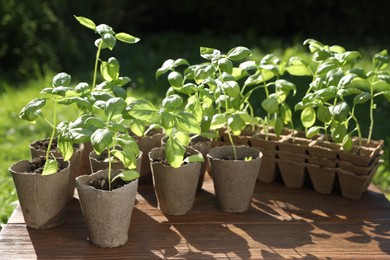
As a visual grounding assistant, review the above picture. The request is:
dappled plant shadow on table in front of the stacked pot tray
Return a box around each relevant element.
[244,184,390,255]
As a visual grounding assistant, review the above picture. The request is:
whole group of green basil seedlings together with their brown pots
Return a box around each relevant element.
[10,17,390,247]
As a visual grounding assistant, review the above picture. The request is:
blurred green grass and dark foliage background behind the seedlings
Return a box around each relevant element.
[0,0,390,228]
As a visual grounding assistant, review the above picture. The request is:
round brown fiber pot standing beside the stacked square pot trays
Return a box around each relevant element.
[207,146,263,212]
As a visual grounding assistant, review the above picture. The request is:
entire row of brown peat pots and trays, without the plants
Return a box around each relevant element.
[10,130,383,247]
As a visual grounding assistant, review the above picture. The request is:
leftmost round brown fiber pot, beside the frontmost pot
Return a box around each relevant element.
[9,159,70,229]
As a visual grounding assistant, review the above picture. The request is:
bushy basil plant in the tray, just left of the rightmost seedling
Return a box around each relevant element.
[289,39,367,151]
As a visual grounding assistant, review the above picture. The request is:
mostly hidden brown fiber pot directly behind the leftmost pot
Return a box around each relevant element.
[30,138,84,200]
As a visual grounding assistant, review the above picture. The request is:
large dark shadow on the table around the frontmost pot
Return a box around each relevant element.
[27,199,181,259]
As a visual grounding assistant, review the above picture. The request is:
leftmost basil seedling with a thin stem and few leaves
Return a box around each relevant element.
[19,72,73,175]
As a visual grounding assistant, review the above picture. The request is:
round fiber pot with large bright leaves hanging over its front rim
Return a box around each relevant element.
[149,147,202,215]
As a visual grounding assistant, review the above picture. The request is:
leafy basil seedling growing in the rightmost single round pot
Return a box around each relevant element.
[193,46,253,159]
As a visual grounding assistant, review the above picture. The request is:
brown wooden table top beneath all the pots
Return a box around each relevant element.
[0,173,390,259]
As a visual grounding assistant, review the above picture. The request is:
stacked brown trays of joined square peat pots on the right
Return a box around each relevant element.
[225,130,383,200]
